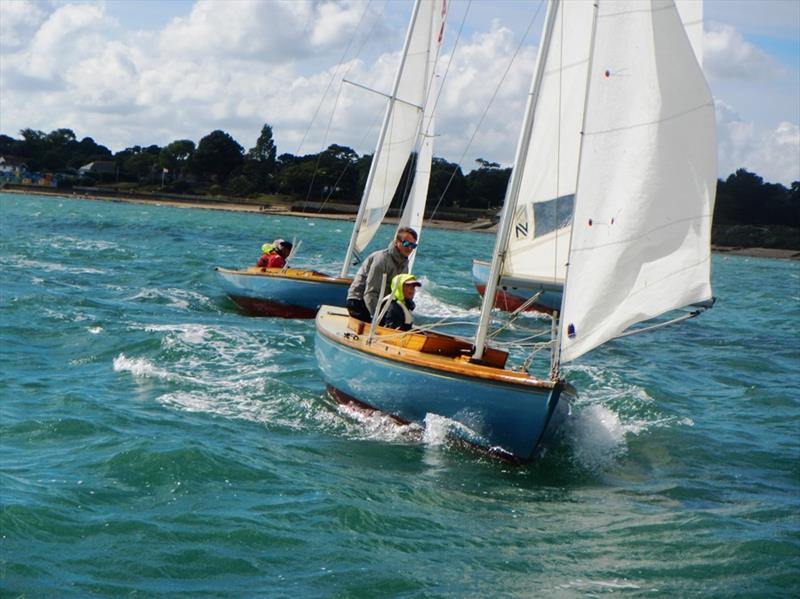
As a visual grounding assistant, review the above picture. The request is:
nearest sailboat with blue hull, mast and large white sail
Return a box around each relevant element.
[315,0,716,462]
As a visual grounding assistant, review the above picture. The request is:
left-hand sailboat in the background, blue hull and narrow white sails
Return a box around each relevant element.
[215,0,446,318]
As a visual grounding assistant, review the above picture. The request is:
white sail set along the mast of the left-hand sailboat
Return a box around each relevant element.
[353,0,445,260]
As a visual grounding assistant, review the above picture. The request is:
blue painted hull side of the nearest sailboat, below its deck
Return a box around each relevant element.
[316,306,572,462]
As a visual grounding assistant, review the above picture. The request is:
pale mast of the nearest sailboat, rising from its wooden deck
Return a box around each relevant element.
[473,0,561,360]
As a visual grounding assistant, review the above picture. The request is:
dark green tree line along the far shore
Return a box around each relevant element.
[0,124,800,227]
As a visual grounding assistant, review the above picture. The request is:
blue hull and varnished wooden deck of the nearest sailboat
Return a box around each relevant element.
[316,314,574,461]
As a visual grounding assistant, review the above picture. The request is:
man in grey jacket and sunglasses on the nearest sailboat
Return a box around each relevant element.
[347,227,417,322]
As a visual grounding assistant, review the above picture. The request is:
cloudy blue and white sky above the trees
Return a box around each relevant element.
[0,0,800,186]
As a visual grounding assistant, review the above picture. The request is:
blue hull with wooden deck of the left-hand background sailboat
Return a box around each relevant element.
[216,268,352,318]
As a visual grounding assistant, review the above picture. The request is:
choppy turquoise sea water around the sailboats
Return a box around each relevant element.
[0,194,800,598]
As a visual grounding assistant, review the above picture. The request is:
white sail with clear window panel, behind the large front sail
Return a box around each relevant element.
[504,2,594,283]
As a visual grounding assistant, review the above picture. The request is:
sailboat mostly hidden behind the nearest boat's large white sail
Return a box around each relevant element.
[472,0,703,314]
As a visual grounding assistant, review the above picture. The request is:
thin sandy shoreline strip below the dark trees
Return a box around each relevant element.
[0,188,800,260]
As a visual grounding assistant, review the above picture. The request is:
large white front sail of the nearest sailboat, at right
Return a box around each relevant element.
[560,0,717,361]
